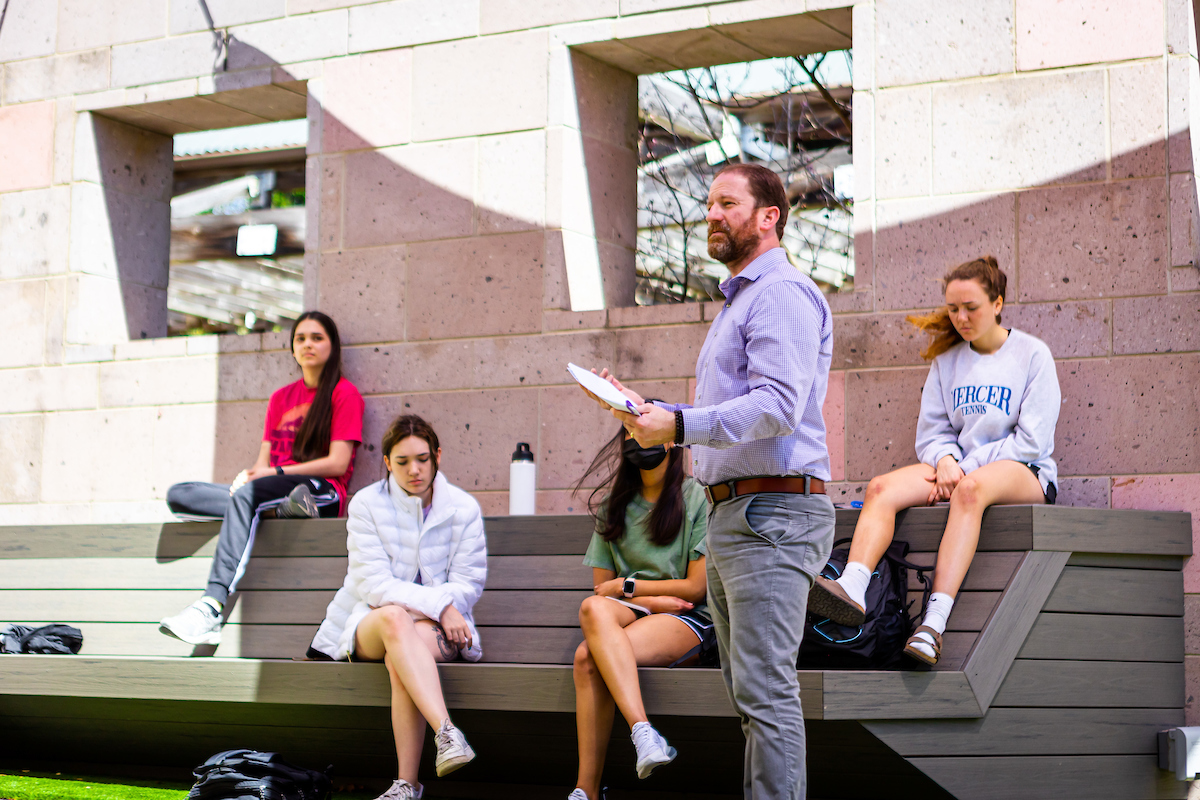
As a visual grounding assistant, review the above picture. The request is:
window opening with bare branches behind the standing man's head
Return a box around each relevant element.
[636,49,854,306]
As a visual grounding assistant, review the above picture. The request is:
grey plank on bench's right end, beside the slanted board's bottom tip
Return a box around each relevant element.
[992,658,1184,709]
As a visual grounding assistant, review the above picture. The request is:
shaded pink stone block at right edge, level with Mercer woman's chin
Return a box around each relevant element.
[1112,294,1200,355]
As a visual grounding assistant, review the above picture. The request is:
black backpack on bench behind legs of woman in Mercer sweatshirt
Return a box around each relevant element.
[797,539,932,669]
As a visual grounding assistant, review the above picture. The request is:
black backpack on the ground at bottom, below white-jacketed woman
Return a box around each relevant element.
[187,750,332,800]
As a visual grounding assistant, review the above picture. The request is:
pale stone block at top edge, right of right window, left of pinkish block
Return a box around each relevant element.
[873,0,1013,86]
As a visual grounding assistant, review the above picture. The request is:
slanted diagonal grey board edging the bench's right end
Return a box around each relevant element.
[962,552,1068,711]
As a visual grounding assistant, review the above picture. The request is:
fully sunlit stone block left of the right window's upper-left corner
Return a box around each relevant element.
[413,31,550,142]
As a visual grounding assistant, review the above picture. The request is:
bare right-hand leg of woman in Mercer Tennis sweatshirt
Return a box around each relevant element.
[934,461,1045,597]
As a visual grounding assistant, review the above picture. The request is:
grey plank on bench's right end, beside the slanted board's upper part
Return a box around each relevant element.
[1044,566,1183,616]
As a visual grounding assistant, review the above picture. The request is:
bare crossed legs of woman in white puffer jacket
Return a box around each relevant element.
[354,606,456,786]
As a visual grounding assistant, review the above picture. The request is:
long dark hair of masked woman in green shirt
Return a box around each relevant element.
[572,428,686,547]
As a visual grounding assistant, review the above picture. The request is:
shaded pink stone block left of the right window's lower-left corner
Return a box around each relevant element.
[407,230,545,339]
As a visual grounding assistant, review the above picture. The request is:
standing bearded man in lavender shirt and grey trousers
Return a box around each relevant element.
[590,164,834,800]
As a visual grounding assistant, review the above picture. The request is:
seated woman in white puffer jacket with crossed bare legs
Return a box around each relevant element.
[308,415,487,800]
